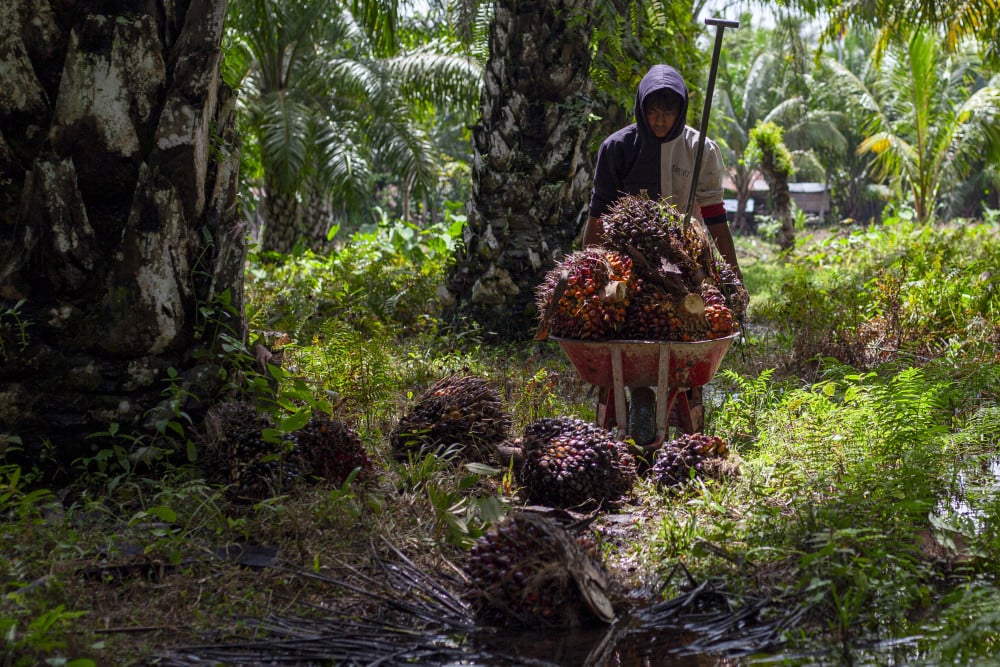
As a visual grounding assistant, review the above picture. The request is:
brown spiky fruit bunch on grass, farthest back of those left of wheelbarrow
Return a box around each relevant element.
[389,373,512,461]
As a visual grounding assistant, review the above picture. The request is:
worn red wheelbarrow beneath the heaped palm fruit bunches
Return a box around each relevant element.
[552,333,739,450]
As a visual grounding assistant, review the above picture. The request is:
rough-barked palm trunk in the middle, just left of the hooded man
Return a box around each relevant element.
[449,0,596,339]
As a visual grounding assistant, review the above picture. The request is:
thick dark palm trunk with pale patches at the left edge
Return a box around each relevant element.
[0,0,246,480]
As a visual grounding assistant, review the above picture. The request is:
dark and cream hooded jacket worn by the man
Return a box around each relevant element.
[590,65,726,224]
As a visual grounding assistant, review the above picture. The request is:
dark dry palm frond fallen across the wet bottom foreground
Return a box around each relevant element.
[157,515,801,667]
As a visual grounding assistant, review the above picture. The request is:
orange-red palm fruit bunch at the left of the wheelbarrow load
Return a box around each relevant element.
[535,247,637,340]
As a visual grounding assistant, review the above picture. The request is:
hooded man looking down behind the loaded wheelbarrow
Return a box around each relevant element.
[583,65,742,438]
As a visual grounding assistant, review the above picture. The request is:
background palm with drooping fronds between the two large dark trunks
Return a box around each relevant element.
[228,0,480,253]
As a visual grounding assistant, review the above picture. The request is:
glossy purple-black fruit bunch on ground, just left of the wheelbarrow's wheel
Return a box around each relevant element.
[518,417,636,509]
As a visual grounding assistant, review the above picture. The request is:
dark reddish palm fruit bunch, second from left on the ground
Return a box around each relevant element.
[292,415,375,486]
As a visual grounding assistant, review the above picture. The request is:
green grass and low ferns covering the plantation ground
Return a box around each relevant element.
[0,211,1000,667]
